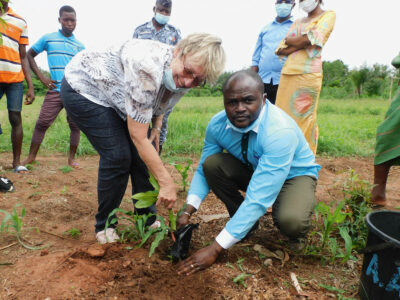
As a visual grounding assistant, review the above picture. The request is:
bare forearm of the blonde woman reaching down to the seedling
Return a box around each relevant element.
[128,116,176,208]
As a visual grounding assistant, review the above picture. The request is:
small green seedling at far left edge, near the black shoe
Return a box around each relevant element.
[0,204,46,250]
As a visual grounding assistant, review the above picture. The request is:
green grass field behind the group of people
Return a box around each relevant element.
[0,96,389,161]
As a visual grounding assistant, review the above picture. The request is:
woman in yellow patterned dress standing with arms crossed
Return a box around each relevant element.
[276,0,336,154]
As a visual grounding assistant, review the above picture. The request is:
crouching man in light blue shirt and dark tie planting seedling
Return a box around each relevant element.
[178,70,320,275]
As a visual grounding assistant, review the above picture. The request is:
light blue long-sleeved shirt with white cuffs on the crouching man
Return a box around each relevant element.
[187,101,321,249]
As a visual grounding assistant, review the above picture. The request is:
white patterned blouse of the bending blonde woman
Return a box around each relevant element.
[65,39,186,123]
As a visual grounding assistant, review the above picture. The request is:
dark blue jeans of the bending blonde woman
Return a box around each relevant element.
[60,79,156,232]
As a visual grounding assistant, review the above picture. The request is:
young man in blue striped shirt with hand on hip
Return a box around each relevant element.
[24,5,85,167]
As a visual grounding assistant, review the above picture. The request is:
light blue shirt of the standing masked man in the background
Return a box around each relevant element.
[251,19,293,85]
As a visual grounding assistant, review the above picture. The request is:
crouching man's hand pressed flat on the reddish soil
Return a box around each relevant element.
[177,241,223,275]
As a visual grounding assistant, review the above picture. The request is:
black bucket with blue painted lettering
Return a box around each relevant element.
[359,211,400,300]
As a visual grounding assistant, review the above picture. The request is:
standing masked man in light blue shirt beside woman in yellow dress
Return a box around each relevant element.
[251,0,295,104]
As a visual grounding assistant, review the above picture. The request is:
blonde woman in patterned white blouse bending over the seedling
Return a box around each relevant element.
[61,34,225,243]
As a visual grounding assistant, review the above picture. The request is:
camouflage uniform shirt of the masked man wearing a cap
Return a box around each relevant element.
[133,21,181,46]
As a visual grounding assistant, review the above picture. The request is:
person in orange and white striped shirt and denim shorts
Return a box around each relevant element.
[0,0,35,172]
